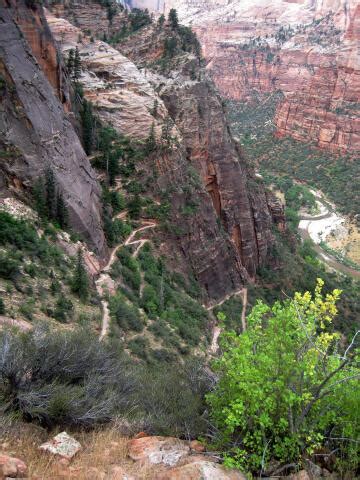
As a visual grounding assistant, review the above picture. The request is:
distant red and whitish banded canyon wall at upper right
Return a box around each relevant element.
[136,0,360,152]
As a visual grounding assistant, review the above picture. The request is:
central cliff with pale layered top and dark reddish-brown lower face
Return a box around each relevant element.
[48,3,283,299]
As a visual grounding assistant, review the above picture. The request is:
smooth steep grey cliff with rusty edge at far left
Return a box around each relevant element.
[0,2,105,255]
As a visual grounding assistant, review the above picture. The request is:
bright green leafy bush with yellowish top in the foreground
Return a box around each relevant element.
[208,279,360,471]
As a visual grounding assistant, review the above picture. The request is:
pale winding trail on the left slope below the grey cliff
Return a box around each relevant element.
[95,216,157,341]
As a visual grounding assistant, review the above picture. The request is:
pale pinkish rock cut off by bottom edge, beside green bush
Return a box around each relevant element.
[156,459,246,480]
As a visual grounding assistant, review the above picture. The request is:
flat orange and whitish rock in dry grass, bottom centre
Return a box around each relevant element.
[128,436,190,466]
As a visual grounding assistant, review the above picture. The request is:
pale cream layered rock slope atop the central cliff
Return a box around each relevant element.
[46,10,167,139]
